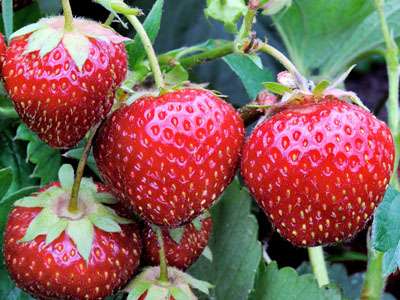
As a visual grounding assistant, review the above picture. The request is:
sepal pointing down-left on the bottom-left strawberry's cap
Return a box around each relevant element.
[20,208,59,243]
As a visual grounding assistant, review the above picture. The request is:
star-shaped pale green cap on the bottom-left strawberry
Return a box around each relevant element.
[14,165,131,262]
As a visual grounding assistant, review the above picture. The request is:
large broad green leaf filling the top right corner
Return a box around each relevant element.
[274,0,400,79]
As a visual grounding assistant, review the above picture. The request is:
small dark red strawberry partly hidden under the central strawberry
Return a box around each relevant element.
[142,217,212,270]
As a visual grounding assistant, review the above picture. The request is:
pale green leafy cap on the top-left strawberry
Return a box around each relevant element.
[10,16,129,71]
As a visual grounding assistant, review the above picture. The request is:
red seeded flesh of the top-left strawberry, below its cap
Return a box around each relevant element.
[3,18,127,148]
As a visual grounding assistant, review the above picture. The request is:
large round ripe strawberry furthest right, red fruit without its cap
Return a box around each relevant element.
[242,97,394,246]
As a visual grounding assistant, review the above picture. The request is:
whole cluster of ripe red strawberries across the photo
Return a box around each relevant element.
[0,6,394,299]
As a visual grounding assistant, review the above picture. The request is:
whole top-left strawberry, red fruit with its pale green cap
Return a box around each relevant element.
[3,17,127,148]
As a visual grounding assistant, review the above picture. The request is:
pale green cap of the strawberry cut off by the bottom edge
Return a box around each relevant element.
[125,267,213,300]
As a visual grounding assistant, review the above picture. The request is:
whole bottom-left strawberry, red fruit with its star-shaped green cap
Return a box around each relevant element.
[4,167,141,299]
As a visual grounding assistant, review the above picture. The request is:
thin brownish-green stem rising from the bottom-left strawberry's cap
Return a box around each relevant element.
[68,122,101,213]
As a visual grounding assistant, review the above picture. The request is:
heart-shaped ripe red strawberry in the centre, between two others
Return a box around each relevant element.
[94,89,244,227]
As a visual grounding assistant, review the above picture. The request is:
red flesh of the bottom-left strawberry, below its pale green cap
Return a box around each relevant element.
[4,185,142,299]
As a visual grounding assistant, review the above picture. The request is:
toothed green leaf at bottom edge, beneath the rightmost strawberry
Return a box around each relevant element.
[249,262,343,300]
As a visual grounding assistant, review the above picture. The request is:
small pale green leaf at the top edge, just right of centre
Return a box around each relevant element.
[204,0,247,33]
